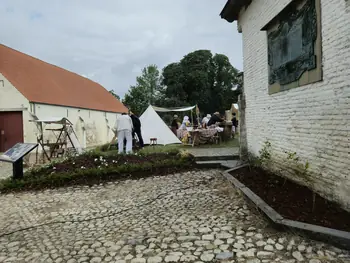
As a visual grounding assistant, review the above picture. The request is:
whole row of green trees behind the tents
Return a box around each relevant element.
[123,50,239,117]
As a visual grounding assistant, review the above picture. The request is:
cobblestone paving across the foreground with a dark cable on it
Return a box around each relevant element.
[0,170,349,263]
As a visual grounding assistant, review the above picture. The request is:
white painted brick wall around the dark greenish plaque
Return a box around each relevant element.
[239,0,350,209]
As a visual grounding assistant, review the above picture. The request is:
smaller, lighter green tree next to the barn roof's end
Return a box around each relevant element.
[123,65,162,115]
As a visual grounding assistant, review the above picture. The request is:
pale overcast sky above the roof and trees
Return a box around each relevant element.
[0,0,242,99]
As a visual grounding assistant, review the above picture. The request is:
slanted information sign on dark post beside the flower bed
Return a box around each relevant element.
[0,143,38,179]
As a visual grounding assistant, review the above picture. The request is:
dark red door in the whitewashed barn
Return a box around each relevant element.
[0,111,23,152]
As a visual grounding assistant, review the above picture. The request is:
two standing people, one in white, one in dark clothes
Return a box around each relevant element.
[114,112,144,154]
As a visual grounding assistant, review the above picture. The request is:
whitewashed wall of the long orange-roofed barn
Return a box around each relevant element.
[0,74,117,152]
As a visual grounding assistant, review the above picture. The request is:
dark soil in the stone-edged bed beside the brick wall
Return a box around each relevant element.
[231,167,350,232]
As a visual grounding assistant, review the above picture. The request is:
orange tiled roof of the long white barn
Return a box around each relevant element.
[0,44,127,112]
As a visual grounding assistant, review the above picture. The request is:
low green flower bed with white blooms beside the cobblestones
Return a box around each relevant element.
[0,151,195,193]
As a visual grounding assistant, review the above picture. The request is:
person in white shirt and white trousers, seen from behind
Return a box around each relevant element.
[114,113,133,154]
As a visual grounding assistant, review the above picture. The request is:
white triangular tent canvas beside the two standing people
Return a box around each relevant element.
[140,106,181,145]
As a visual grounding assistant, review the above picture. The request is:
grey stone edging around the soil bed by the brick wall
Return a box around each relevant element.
[222,164,350,250]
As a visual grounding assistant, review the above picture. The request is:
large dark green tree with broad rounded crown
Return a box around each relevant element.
[162,50,238,113]
